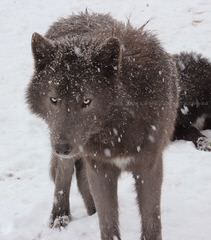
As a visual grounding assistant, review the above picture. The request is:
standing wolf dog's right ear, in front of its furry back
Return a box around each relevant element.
[94,37,121,75]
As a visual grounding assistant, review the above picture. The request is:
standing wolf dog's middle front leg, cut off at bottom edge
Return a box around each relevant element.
[87,161,120,240]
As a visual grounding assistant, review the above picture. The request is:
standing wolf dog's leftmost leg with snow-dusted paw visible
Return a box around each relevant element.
[50,155,74,228]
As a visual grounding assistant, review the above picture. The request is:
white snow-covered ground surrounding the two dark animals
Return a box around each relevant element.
[0,0,211,240]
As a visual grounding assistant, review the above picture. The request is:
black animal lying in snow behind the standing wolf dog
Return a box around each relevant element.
[173,52,211,151]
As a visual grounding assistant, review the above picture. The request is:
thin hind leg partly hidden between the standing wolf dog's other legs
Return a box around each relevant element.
[75,159,96,215]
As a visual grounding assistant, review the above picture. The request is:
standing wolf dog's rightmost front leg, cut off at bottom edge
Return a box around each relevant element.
[133,157,162,240]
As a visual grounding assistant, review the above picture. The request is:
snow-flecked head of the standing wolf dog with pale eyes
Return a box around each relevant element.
[27,33,120,157]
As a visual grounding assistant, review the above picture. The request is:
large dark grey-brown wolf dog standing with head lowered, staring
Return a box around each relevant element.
[27,12,178,240]
